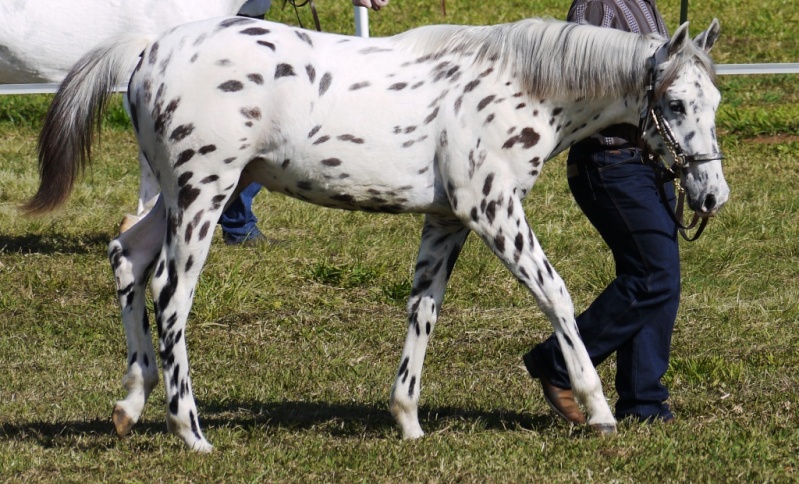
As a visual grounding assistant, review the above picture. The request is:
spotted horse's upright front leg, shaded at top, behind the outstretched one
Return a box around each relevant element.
[389,215,469,439]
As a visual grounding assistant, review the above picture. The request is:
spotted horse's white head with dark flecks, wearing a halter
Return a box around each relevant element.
[641,19,730,217]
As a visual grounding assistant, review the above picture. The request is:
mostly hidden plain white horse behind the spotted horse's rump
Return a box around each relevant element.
[0,0,272,231]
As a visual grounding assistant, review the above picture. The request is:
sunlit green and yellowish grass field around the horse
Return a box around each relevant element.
[0,0,799,482]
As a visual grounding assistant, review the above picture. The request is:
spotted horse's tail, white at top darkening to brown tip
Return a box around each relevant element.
[22,36,152,214]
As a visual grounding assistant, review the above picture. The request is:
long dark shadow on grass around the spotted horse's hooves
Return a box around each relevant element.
[0,400,559,450]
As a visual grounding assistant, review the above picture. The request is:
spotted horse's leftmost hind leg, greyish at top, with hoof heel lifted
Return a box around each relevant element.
[108,195,166,436]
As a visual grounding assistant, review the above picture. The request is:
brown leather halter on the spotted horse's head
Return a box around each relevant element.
[638,56,724,242]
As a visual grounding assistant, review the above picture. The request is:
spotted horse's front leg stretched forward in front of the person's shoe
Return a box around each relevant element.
[466,189,616,433]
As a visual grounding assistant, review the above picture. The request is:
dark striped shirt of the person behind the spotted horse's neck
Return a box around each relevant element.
[567,0,669,147]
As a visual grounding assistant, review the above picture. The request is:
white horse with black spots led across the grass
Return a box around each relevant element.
[27,18,729,451]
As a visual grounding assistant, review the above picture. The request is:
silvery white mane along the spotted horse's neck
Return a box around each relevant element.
[395,19,665,99]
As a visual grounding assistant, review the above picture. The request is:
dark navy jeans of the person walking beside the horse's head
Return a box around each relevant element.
[524,144,680,420]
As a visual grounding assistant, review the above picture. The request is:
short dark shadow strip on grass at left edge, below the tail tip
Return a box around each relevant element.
[0,232,113,255]
